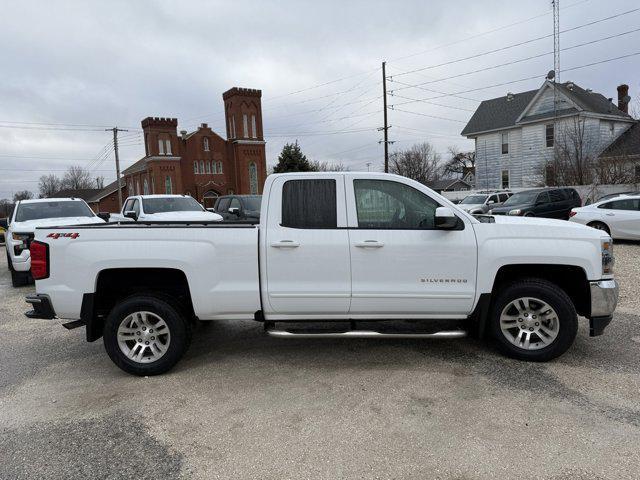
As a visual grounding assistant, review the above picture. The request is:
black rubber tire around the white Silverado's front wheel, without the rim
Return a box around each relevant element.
[489,278,578,362]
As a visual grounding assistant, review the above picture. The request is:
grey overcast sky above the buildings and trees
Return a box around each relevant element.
[0,0,640,198]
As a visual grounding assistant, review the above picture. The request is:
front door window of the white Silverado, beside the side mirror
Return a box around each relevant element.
[353,180,439,230]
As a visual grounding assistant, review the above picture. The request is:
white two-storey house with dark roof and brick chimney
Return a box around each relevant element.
[462,81,634,189]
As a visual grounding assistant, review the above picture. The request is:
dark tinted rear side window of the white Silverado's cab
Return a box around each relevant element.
[282,179,338,228]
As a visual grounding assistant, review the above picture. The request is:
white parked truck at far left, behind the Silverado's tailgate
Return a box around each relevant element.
[2,198,104,287]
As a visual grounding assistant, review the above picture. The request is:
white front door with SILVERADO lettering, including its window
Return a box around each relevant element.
[346,174,477,318]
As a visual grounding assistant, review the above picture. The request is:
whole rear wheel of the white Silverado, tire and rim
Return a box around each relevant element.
[103,295,191,375]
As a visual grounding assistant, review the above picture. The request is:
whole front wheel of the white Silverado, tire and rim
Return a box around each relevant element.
[490,279,578,362]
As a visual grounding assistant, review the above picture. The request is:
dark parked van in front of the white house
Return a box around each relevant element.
[489,188,582,220]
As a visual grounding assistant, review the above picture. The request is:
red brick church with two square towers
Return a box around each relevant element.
[114,87,267,210]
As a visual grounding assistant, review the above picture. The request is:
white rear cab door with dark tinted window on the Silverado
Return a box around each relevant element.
[261,174,351,318]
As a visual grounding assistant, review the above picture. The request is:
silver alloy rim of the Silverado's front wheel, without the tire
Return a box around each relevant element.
[500,297,560,350]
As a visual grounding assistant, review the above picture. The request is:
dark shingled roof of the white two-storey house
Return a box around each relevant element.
[461,81,631,135]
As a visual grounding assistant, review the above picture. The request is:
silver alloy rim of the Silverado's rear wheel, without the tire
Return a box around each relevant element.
[118,312,171,363]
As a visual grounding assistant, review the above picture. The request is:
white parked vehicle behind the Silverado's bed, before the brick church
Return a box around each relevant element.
[110,195,222,222]
